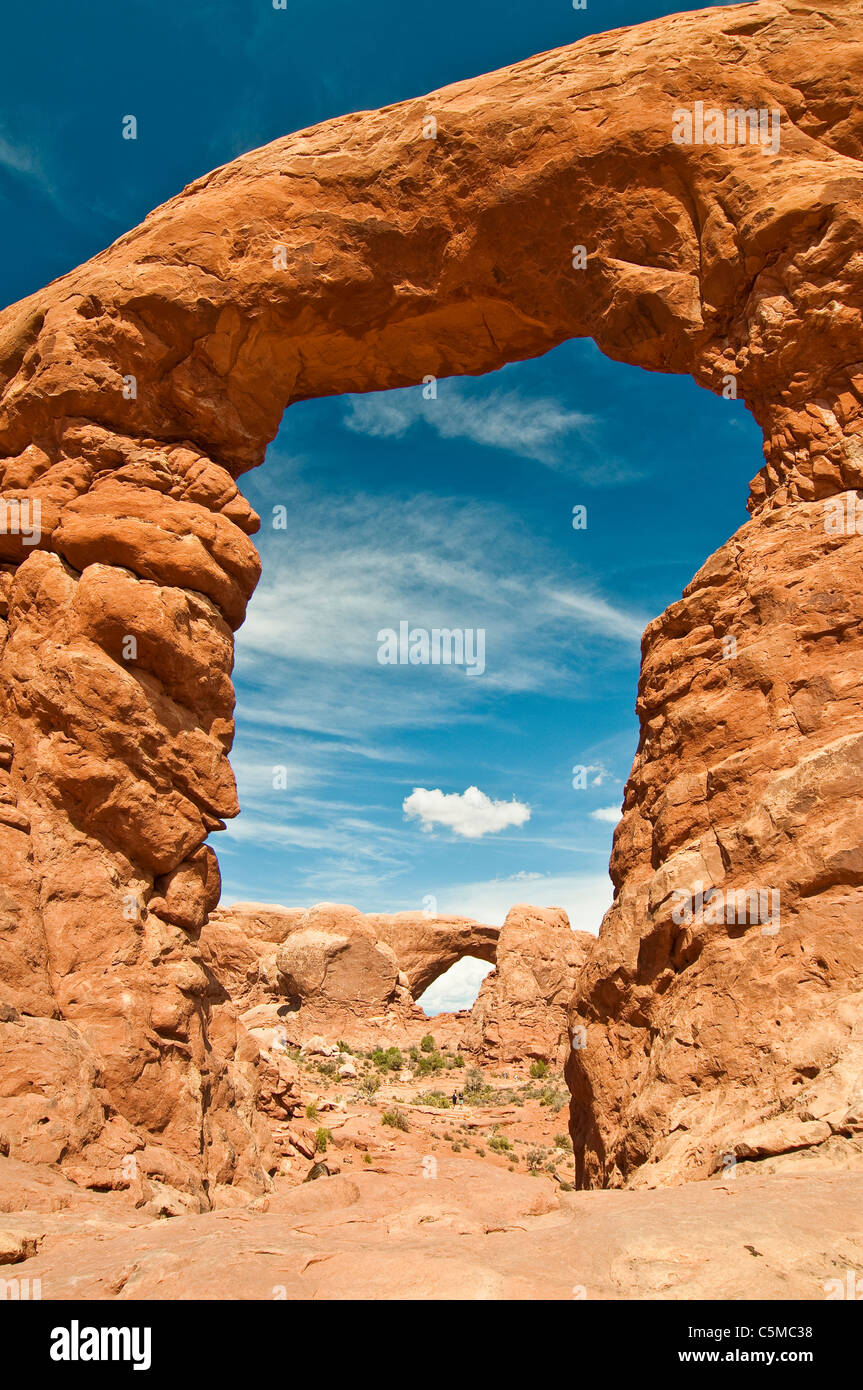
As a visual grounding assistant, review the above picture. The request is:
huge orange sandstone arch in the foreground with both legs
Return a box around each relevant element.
[0,0,863,1200]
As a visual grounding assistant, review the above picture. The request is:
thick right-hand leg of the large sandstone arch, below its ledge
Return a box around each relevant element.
[568,502,863,1186]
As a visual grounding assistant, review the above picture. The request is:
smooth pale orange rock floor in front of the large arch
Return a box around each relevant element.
[0,1136,863,1305]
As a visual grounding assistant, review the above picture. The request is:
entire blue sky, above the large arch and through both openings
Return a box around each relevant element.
[0,0,744,1006]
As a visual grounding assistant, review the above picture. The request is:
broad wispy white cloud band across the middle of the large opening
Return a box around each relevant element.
[238,484,646,706]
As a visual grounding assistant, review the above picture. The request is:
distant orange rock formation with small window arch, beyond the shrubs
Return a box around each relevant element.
[200,902,596,1065]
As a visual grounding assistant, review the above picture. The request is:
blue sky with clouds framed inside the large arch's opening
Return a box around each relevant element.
[230,341,760,1011]
